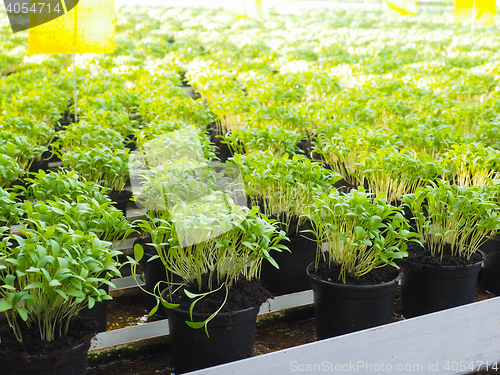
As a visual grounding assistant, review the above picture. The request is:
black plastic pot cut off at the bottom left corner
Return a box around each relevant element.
[0,344,90,375]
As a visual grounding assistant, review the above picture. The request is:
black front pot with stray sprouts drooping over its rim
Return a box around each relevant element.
[168,307,259,373]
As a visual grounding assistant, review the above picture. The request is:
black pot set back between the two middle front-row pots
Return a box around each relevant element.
[260,236,317,295]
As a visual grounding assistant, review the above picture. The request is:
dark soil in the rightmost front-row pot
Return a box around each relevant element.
[396,242,483,269]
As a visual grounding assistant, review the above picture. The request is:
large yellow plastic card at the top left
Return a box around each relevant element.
[28,0,116,55]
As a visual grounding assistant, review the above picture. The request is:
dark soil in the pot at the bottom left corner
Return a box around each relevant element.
[0,316,98,362]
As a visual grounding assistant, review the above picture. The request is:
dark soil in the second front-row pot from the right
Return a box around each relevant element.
[309,260,399,285]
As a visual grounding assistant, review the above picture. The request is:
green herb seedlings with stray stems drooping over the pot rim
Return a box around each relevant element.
[133,203,286,335]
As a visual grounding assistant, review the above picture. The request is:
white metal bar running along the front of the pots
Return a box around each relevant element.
[186,298,500,375]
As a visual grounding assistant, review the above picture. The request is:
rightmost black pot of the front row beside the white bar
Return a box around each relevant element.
[401,261,483,318]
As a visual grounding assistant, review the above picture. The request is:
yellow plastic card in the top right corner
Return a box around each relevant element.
[453,0,497,25]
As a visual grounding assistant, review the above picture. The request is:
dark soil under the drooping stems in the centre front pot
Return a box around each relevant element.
[167,275,271,313]
